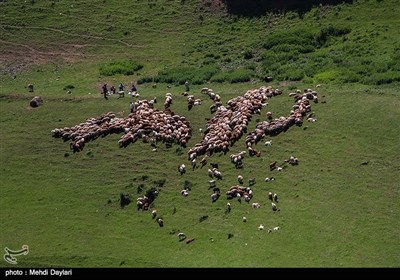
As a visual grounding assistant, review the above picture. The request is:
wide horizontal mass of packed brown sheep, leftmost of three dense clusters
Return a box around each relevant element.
[51,100,191,152]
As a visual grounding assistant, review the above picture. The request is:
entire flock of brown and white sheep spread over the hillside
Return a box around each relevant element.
[51,86,318,240]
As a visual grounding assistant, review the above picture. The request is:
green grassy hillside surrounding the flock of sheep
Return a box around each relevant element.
[0,0,400,267]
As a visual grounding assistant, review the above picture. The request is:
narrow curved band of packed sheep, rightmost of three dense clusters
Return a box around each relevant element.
[246,89,318,150]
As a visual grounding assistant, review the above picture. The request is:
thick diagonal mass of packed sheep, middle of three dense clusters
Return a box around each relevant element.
[188,87,279,160]
